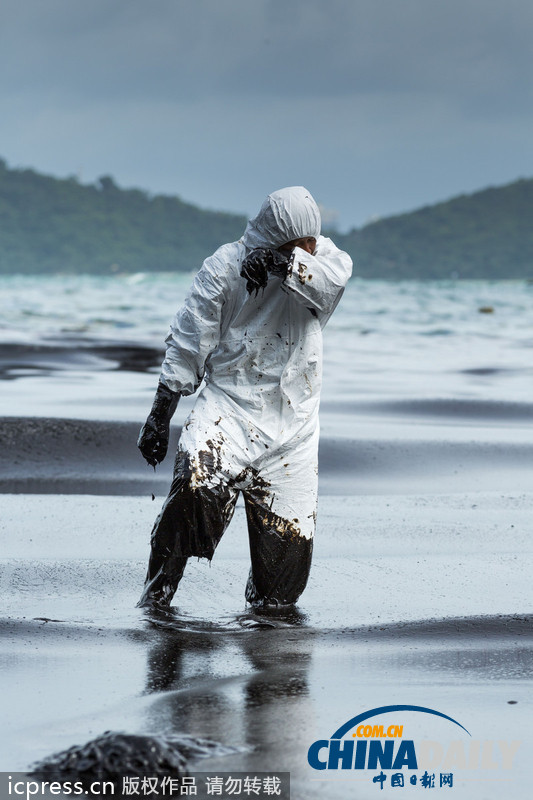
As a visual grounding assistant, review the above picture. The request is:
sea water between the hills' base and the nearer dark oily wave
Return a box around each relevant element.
[0,273,533,422]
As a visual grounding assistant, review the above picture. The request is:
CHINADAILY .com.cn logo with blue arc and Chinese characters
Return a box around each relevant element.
[307,705,521,789]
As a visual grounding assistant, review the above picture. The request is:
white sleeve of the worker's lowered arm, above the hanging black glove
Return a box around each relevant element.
[161,251,227,395]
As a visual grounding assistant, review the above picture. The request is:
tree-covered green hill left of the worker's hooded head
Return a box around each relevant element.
[0,161,246,274]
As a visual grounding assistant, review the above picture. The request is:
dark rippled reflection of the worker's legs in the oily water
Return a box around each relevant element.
[144,620,317,768]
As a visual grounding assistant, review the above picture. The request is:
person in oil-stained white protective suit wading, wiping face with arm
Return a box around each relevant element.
[138,186,352,606]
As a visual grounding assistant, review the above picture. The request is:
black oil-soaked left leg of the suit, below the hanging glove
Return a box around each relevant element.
[138,450,238,606]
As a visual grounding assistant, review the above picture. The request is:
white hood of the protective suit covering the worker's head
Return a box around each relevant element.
[242,186,320,250]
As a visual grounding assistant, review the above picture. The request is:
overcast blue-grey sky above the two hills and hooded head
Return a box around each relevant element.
[0,0,533,229]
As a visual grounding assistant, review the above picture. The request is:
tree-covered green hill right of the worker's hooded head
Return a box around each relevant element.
[336,179,533,278]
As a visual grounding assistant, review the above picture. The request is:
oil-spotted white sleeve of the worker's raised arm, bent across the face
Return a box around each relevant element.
[282,236,352,324]
